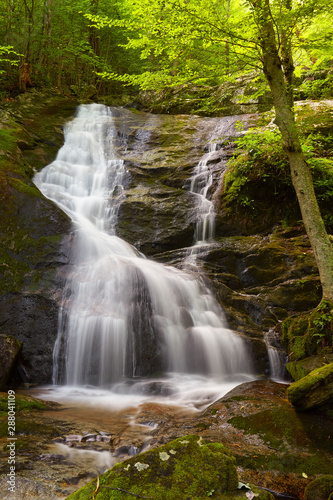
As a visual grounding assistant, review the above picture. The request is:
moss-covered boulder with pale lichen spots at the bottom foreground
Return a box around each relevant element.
[68,435,238,500]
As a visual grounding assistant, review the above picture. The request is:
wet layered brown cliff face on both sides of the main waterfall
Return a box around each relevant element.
[0,92,320,384]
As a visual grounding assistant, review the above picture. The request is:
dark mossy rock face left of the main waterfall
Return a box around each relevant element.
[0,94,73,383]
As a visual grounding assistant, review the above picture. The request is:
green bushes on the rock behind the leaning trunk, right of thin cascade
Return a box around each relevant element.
[223,108,333,232]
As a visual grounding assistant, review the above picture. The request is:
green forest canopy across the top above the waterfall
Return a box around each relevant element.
[0,0,333,98]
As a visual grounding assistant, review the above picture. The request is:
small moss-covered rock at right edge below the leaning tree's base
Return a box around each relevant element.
[287,363,333,411]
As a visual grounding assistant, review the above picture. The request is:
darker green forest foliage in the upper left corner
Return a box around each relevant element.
[0,0,141,93]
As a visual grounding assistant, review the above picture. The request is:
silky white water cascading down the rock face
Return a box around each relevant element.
[35,104,251,408]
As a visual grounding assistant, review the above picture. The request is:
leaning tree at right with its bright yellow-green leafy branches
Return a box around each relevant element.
[88,0,333,302]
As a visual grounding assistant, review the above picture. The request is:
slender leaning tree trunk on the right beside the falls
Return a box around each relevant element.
[251,0,333,302]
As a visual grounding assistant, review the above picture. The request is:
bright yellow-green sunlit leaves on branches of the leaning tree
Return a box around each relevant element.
[82,0,332,94]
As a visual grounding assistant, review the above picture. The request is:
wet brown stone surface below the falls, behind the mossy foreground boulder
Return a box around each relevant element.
[0,380,333,500]
